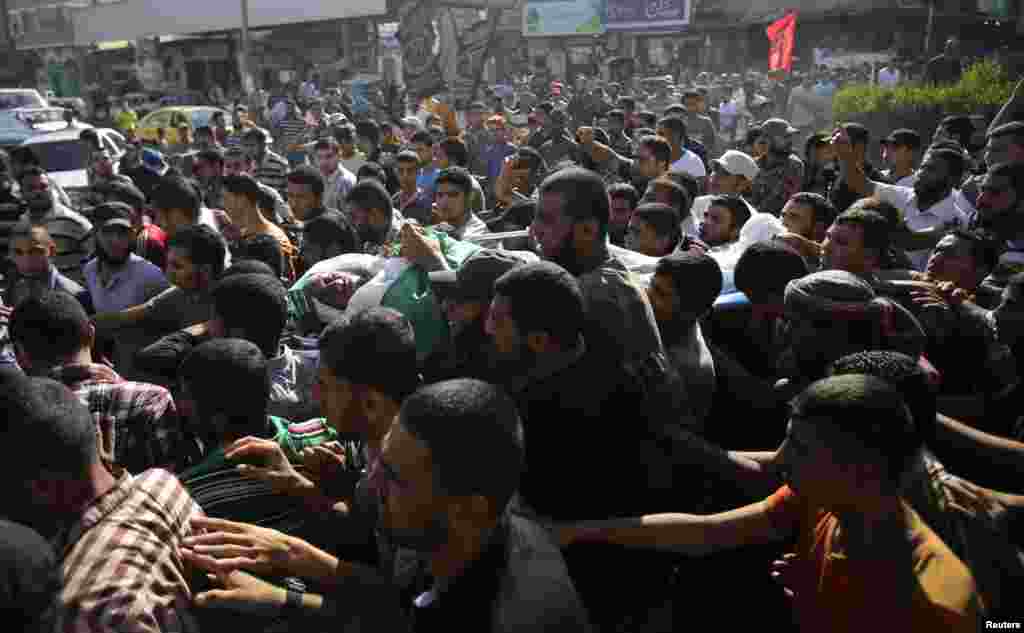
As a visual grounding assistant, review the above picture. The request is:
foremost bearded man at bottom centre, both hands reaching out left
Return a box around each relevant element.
[185,379,590,633]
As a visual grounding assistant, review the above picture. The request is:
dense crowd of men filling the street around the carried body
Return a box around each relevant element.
[0,56,1024,633]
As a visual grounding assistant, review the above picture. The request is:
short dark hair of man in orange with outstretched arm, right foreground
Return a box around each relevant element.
[792,374,922,487]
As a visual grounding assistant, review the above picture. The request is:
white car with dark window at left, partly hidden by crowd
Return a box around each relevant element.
[19,123,126,203]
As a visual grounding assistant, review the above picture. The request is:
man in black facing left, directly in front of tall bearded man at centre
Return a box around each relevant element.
[486,262,674,630]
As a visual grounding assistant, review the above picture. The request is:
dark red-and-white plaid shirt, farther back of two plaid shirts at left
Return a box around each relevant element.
[51,365,198,472]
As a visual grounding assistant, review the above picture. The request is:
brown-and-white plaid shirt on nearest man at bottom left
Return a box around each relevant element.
[53,470,203,633]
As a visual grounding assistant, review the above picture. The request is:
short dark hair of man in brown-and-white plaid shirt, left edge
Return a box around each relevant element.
[0,377,98,475]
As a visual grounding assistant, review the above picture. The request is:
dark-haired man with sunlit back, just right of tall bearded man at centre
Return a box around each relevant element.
[647,252,722,433]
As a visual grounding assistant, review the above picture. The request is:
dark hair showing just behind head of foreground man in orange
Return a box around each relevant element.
[827,350,937,444]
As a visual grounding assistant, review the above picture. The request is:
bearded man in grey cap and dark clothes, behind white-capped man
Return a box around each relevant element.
[751,119,802,216]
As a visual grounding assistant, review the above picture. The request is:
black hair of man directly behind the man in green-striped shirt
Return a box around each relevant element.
[211,275,288,357]
